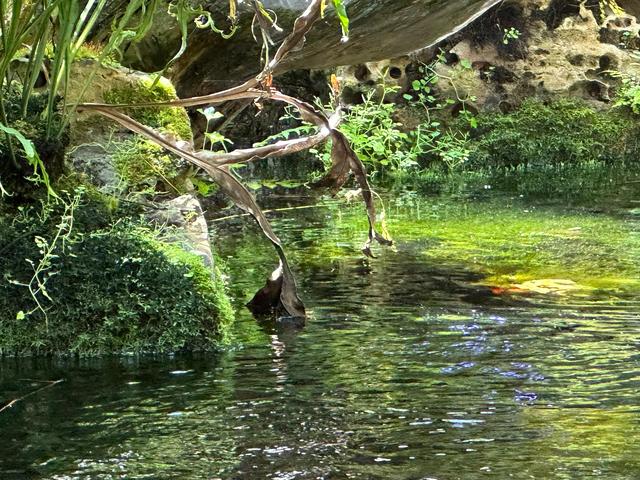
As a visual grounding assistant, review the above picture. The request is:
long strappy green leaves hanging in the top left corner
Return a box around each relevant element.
[0,0,162,193]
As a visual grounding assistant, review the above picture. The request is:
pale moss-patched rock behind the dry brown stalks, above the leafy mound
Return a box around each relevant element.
[68,59,192,193]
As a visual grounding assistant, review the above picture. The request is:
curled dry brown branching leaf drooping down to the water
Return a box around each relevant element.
[78,0,392,317]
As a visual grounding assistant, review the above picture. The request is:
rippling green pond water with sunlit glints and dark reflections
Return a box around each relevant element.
[0,196,640,480]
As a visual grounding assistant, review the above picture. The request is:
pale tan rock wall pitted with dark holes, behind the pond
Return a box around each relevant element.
[340,0,640,114]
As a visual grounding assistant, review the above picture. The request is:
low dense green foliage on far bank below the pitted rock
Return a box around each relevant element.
[470,99,640,168]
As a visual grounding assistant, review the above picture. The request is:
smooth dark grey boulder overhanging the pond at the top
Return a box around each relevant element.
[107,0,500,97]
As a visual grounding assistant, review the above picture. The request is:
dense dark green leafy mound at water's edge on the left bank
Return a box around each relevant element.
[0,190,232,354]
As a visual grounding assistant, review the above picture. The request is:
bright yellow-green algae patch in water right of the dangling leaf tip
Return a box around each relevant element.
[391,201,640,290]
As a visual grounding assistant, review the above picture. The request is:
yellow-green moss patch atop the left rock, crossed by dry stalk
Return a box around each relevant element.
[104,78,192,140]
